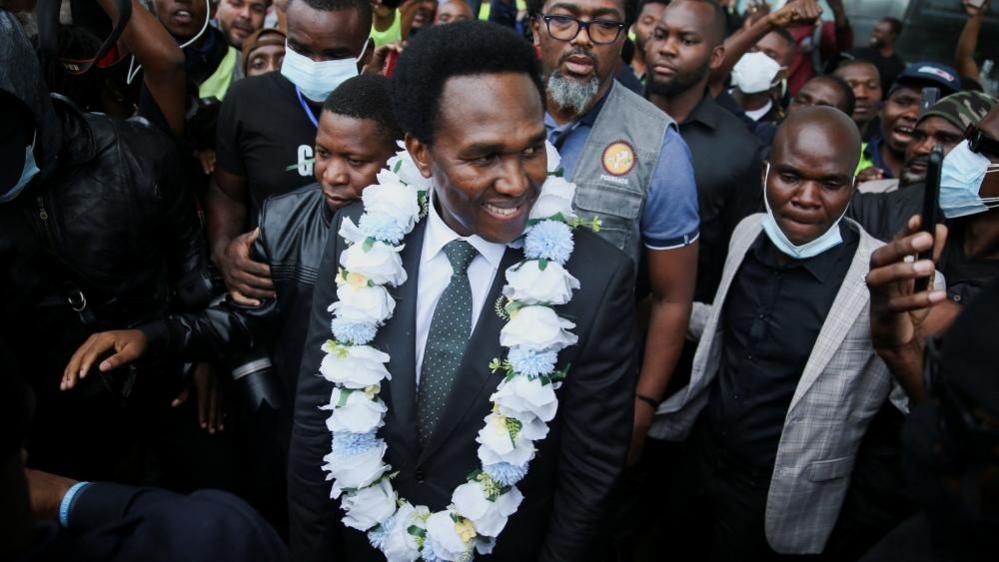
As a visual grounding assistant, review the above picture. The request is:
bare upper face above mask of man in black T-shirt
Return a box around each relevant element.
[287,0,371,61]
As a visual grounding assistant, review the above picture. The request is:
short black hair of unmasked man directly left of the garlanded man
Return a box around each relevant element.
[323,74,402,145]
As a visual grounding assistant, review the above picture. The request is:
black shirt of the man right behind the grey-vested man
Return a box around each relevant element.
[680,95,763,302]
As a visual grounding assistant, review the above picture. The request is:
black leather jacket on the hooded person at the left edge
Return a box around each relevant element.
[0,97,209,376]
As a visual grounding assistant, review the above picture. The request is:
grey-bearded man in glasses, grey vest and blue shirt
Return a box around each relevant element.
[528,0,699,462]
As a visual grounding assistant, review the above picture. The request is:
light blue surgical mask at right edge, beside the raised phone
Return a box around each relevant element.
[940,140,999,219]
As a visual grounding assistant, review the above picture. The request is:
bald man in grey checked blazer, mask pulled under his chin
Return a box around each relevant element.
[650,107,904,560]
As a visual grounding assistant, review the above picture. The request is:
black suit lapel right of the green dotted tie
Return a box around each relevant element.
[419,248,523,463]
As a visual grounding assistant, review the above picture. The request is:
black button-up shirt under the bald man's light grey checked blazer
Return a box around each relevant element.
[707,222,860,467]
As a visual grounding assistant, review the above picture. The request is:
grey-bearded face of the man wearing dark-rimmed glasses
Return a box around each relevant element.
[531,0,625,114]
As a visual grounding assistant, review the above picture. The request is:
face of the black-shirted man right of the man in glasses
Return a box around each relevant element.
[645,2,724,97]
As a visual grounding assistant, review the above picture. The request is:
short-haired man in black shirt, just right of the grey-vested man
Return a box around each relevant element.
[645,2,761,302]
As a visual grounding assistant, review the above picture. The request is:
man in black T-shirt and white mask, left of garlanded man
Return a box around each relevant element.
[205,0,371,305]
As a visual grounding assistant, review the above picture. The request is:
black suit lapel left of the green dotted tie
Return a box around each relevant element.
[374,220,427,451]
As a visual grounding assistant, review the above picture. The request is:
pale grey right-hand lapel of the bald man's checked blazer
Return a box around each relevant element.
[788,222,873,413]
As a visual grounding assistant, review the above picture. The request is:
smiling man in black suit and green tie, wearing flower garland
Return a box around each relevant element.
[289,22,637,561]
